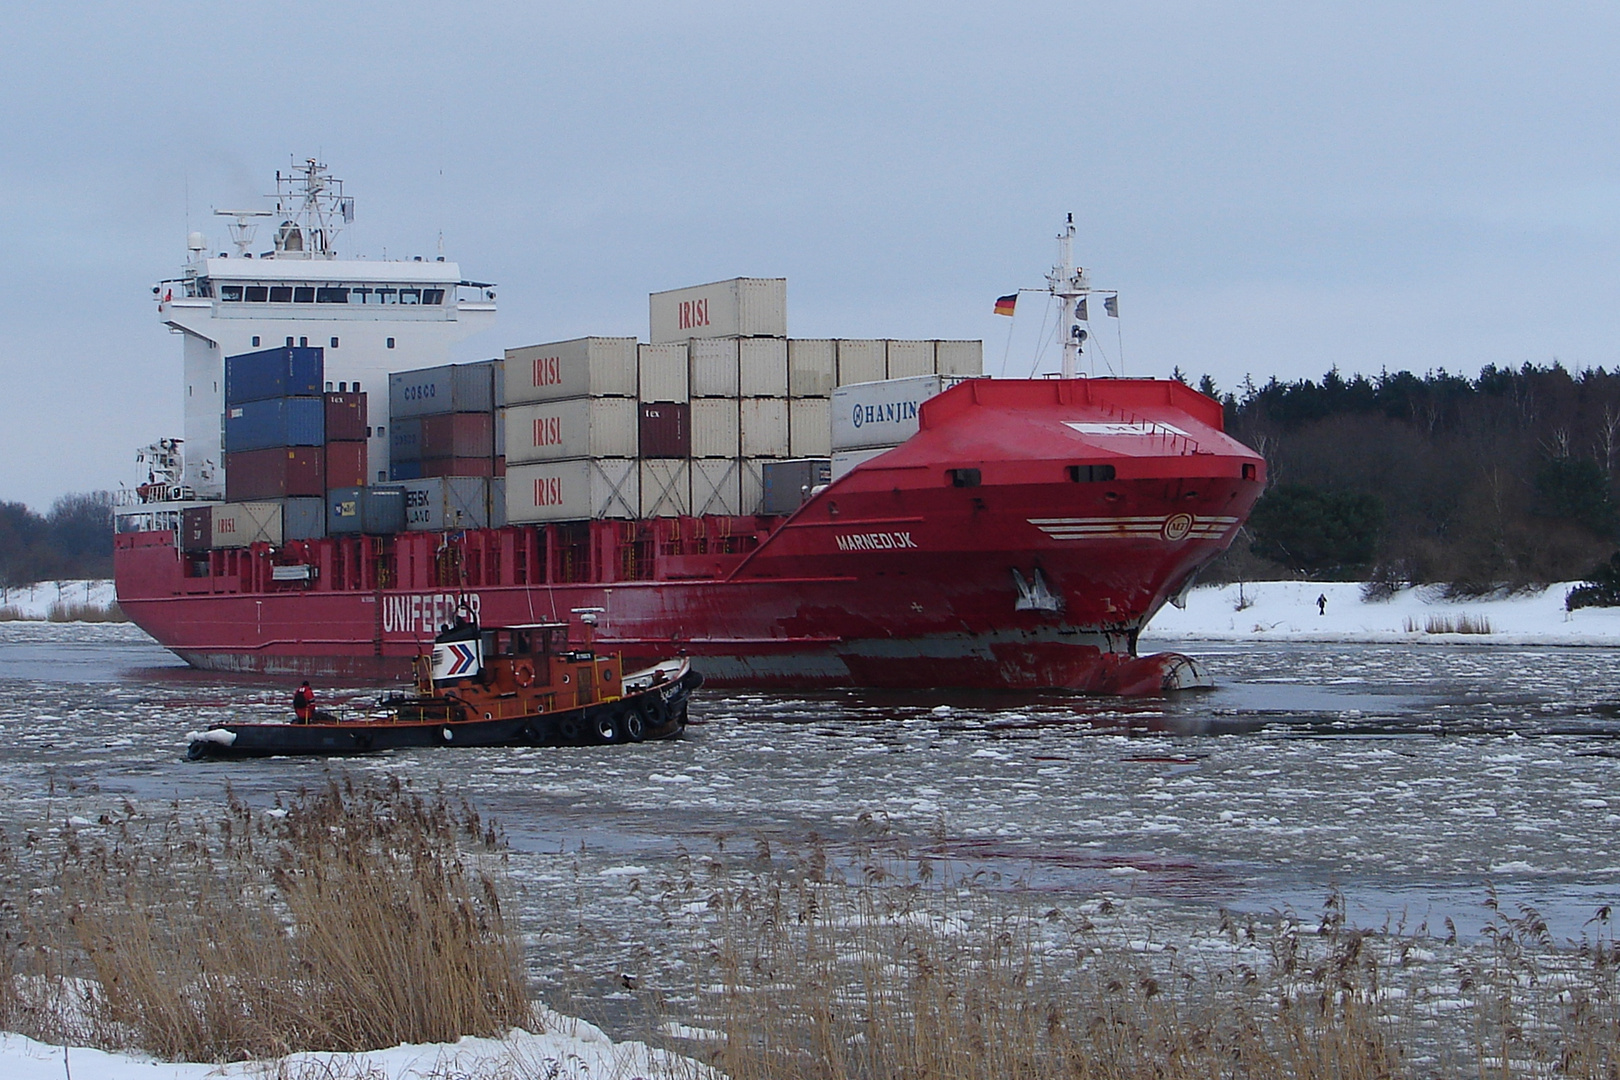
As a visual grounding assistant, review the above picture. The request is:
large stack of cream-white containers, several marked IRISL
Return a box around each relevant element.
[498,279,983,521]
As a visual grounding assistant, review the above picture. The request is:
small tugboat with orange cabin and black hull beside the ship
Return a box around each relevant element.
[186,615,703,761]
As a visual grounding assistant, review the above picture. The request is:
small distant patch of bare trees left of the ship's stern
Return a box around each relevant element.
[0,491,113,586]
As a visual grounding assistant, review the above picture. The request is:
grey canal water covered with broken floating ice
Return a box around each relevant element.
[0,623,1620,1016]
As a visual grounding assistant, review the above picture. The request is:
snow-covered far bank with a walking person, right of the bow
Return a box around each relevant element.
[1142,581,1620,644]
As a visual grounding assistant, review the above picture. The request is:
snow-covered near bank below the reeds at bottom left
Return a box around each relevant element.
[0,1012,719,1080]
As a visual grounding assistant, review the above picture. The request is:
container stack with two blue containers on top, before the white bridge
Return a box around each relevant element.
[212,347,366,547]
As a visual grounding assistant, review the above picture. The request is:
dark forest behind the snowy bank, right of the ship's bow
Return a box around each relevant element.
[1199,363,1620,594]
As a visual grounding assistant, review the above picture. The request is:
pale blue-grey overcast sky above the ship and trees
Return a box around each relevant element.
[0,0,1620,508]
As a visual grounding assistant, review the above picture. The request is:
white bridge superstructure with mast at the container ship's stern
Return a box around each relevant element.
[156,159,496,499]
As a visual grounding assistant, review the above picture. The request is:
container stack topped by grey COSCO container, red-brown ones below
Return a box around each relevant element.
[387,359,505,531]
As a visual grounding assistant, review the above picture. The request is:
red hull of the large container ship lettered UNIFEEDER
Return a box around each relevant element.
[115,381,1264,693]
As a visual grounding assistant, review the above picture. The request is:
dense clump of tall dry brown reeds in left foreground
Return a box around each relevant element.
[0,784,530,1061]
